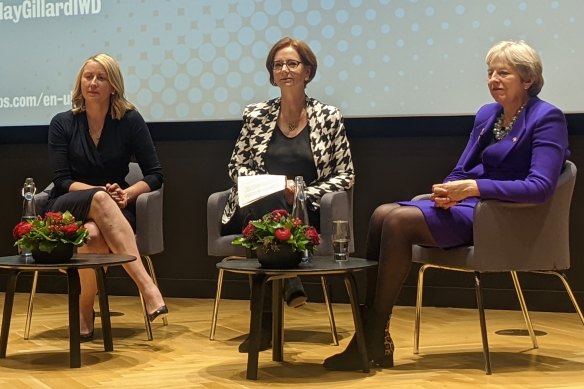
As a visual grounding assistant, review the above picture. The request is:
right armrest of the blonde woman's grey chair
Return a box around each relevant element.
[136,185,164,255]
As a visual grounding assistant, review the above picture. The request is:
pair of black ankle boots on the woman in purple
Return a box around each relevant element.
[323,308,395,371]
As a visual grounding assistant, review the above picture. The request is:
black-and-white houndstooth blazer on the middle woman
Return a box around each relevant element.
[221,97,355,224]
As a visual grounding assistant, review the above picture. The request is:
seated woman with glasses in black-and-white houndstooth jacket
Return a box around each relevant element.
[222,37,355,352]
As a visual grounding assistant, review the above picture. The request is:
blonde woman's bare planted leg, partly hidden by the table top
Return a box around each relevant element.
[78,221,110,334]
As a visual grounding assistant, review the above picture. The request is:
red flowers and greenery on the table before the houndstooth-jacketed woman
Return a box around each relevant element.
[231,209,320,252]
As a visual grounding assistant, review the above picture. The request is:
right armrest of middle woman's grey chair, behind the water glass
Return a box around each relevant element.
[317,188,355,255]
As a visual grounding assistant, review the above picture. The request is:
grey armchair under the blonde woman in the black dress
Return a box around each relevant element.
[24,162,168,340]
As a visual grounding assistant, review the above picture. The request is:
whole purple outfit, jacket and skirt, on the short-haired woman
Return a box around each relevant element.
[399,97,570,248]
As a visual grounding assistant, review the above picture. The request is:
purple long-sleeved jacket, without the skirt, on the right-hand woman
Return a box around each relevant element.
[444,97,570,203]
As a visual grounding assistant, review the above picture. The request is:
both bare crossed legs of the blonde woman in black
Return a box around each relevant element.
[79,191,164,333]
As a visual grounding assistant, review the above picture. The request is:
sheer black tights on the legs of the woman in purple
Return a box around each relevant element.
[366,204,436,326]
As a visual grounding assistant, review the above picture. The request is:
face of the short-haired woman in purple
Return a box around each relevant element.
[487,58,532,107]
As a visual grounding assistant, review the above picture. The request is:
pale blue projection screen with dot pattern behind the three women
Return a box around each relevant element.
[0,0,584,126]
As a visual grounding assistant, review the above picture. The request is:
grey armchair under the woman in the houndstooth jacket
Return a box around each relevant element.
[207,189,354,345]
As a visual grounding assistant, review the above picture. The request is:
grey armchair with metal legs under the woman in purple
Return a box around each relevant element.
[412,161,584,374]
